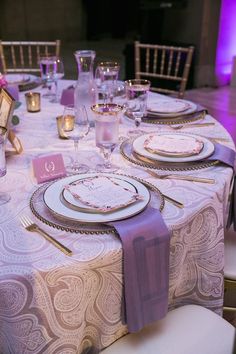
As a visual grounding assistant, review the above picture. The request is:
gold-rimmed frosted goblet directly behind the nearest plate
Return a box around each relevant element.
[91,103,123,172]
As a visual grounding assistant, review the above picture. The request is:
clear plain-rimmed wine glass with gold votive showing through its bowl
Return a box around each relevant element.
[61,105,89,174]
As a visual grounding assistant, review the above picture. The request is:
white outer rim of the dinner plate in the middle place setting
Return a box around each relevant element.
[133,132,215,162]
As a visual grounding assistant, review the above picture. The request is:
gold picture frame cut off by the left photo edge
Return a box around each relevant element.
[0,88,15,131]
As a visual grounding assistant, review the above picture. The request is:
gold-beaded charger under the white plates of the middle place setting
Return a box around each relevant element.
[120,136,219,171]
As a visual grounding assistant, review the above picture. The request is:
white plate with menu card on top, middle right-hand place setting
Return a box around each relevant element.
[133,132,214,163]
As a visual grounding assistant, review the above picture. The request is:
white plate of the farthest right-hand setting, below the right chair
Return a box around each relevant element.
[147,99,197,118]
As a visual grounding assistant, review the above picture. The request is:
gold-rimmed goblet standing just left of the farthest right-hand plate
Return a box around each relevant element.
[125,79,151,137]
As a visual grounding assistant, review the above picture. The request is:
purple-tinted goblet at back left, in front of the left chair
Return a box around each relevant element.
[39,55,56,99]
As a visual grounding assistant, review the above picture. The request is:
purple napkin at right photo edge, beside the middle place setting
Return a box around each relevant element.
[205,143,236,231]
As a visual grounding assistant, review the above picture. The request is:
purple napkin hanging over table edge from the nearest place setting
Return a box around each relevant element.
[109,207,170,332]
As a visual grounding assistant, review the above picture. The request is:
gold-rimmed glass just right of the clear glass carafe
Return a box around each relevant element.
[95,61,120,103]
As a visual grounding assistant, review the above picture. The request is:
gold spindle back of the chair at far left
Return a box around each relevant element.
[0,40,61,74]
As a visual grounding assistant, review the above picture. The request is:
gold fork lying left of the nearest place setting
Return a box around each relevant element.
[20,215,72,256]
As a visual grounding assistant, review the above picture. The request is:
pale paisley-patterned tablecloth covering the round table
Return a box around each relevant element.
[0,81,234,354]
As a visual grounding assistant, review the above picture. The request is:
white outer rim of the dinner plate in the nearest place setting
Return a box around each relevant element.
[43,173,151,223]
